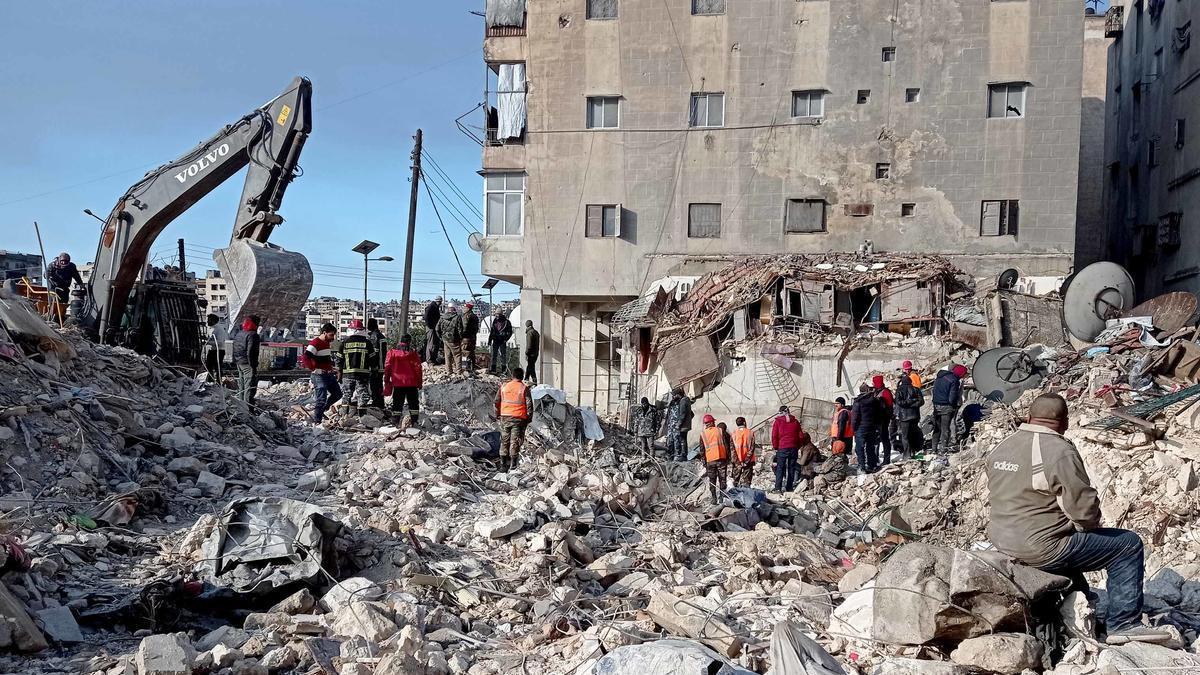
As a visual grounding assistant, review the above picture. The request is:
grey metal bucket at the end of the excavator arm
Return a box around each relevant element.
[212,239,312,328]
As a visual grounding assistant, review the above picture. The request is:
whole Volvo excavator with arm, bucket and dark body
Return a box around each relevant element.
[80,77,312,364]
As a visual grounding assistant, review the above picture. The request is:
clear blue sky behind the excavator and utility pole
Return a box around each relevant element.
[0,0,501,299]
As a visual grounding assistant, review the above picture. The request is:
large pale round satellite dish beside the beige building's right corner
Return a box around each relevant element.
[1062,262,1134,341]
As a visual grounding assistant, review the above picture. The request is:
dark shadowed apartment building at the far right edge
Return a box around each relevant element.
[1104,0,1200,298]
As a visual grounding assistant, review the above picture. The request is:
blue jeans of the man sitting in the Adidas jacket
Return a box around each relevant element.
[1040,527,1146,633]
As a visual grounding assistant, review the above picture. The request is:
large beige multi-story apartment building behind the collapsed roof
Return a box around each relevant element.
[476,0,1084,411]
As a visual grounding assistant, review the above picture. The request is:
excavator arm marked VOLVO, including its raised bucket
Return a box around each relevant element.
[84,77,312,339]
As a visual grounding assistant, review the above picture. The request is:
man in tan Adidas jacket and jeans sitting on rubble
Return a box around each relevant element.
[988,394,1170,645]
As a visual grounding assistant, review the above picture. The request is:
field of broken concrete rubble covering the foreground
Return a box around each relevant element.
[0,270,1200,675]
